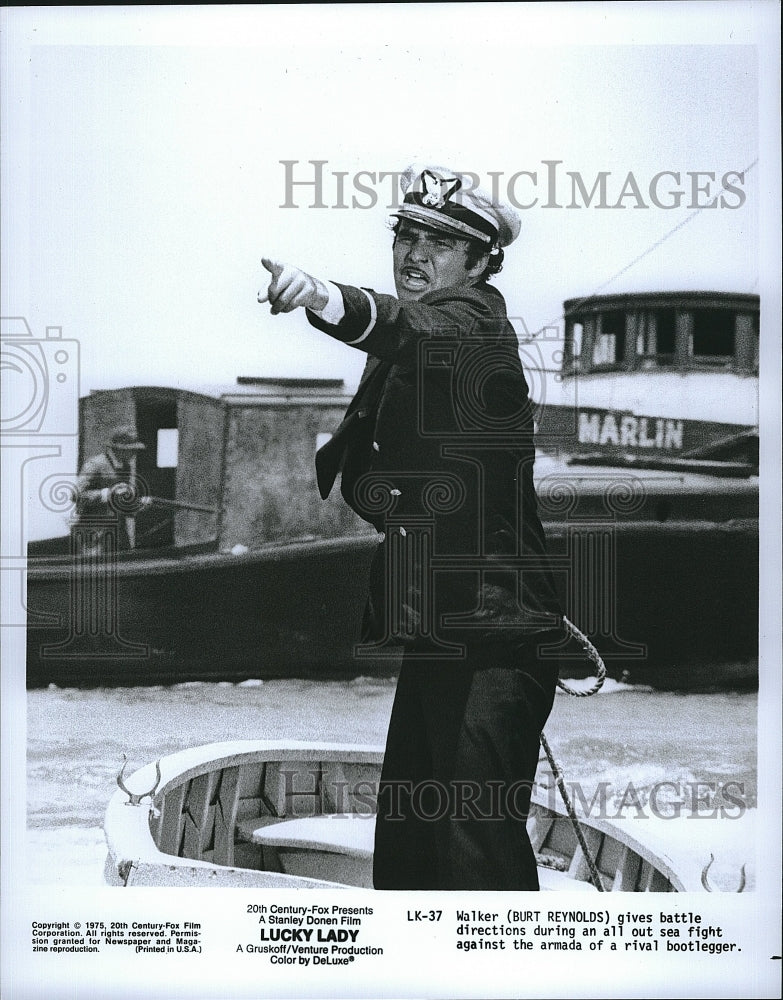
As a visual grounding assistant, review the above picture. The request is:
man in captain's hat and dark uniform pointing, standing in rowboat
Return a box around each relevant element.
[258,165,563,890]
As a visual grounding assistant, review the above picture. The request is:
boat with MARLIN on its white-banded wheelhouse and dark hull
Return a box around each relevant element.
[522,291,759,690]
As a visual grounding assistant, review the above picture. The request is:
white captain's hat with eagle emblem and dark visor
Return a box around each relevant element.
[392,163,522,247]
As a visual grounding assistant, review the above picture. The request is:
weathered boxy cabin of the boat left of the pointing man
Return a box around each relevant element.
[79,377,361,551]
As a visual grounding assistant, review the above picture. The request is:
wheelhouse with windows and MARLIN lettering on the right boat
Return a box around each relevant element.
[537,292,759,464]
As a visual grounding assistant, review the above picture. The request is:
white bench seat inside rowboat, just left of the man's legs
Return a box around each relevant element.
[247,813,375,861]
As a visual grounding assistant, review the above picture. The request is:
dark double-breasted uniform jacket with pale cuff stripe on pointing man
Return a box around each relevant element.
[308,283,561,643]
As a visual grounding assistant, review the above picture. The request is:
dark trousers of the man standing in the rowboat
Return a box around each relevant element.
[373,633,561,890]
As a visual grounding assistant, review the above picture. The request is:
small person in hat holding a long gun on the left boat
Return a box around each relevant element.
[71,427,152,554]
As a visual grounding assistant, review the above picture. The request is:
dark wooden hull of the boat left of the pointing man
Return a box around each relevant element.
[27,537,388,685]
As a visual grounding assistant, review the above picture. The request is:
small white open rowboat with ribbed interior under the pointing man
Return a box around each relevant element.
[104,740,703,892]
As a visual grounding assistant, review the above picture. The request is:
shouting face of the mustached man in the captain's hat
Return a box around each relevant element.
[393,225,486,301]
